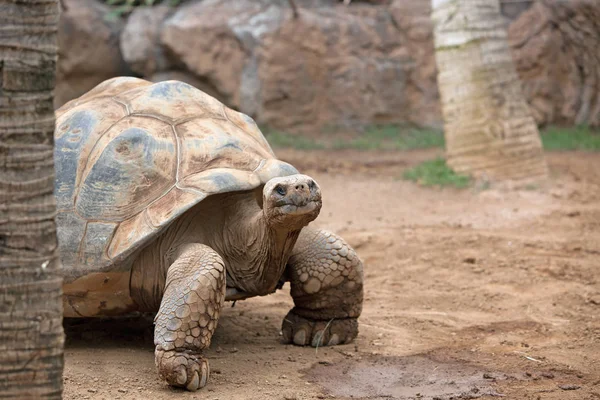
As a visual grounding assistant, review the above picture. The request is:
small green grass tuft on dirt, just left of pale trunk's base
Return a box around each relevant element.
[403,157,471,189]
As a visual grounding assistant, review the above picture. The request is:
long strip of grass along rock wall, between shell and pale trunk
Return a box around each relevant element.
[263,125,444,150]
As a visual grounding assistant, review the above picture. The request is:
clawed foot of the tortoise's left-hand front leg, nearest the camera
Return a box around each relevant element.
[155,348,210,392]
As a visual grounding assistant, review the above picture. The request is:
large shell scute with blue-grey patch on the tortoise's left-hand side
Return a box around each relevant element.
[75,117,177,222]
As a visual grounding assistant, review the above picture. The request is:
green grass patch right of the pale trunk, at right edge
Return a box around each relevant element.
[541,126,600,151]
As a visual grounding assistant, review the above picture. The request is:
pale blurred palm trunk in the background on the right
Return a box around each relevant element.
[432,0,547,181]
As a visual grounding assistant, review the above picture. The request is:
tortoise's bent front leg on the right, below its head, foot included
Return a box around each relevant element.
[282,228,363,347]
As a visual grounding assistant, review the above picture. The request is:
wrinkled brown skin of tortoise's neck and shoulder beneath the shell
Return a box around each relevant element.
[130,192,302,311]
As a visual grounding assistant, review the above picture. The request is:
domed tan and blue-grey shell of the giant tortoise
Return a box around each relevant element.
[54,77,298,282]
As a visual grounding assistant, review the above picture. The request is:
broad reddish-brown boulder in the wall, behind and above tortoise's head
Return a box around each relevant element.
[256,3,416,131]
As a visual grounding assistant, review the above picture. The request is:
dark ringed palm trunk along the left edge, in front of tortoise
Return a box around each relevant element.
[0,0,64,399]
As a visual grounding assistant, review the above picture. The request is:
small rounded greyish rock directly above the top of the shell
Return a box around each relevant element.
[120,6,174,77]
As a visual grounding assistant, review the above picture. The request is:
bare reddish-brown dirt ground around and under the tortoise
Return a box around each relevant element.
[64,150,600,400]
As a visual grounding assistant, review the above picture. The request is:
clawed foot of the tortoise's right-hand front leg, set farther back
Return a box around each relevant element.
[281,310,358,347]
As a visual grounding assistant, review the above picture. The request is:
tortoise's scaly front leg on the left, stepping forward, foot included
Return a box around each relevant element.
[154,244,225,391]
